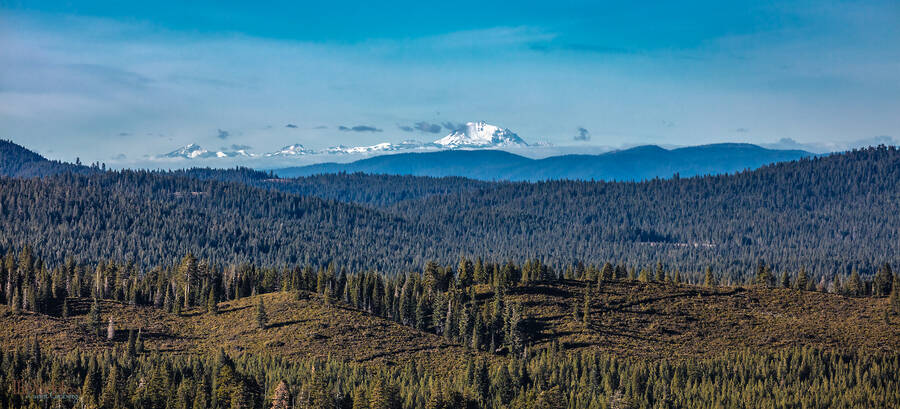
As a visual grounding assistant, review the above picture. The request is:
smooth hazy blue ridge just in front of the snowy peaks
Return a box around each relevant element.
[274,144,813,181]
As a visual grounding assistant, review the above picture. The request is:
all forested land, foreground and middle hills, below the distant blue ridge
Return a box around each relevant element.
[0,142,900,409]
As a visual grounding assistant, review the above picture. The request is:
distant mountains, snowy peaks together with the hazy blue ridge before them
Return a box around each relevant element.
[157,121,813,181]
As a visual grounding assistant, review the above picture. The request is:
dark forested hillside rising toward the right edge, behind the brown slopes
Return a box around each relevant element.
[391,147,900,277]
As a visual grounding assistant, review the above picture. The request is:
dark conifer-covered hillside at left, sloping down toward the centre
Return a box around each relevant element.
[0,171,411,268]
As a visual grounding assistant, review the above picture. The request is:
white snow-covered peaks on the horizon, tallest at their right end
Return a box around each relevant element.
[157,121,528,159]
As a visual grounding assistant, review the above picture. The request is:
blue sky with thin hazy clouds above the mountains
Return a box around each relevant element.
[0,0,900,163]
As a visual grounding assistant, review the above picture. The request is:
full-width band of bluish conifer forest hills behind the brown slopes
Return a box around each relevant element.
[0,142,900,285]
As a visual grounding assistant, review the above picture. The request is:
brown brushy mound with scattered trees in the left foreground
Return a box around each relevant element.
[0,292,467,368]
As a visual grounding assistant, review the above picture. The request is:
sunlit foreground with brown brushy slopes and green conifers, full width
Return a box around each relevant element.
[0,244,900,408]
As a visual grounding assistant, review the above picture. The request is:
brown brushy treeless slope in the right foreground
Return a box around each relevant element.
[502,280,900,359]
